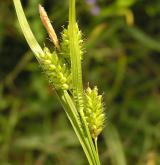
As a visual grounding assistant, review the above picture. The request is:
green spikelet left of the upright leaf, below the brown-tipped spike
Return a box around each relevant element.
[38,48,71,90]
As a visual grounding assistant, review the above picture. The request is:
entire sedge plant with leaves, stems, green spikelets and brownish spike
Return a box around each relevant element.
[13,0,105,165]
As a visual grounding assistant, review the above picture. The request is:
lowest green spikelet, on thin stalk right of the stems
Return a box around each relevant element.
[84,87,105,139]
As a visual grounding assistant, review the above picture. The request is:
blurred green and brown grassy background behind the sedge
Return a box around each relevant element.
[0,0,160,165]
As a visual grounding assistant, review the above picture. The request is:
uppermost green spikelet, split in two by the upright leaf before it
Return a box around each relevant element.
[61,24,83,64]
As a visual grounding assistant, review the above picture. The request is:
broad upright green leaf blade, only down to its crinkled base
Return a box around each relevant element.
[69,0,83,102]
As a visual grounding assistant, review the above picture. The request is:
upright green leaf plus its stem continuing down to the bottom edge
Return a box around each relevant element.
[69,0,100,165]
